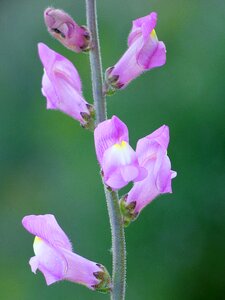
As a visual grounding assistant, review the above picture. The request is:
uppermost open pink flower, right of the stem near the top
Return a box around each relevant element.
[106,12,166,89]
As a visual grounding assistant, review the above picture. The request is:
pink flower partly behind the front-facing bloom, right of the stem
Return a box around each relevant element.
[121,125,176,225]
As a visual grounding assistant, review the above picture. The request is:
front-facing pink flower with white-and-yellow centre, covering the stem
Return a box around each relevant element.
[94,116,147,190]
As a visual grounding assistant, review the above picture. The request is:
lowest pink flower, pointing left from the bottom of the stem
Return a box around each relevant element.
[22,215,110,290]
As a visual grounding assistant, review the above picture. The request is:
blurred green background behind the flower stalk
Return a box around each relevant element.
[0,0,225,300]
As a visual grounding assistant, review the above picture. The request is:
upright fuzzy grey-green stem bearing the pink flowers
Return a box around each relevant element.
[86,0,126,300]
